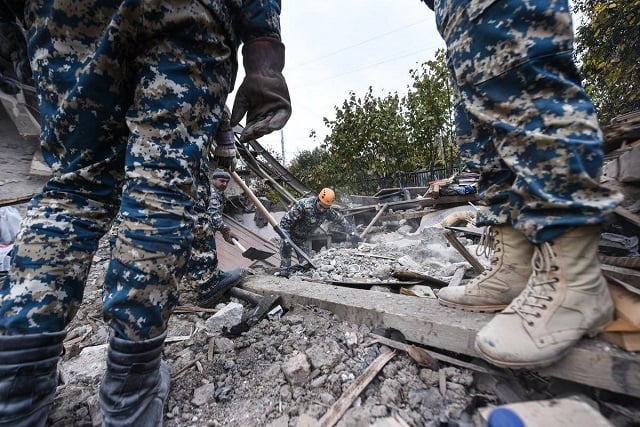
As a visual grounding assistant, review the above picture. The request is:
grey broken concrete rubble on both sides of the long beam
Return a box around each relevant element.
[25,209,640,427]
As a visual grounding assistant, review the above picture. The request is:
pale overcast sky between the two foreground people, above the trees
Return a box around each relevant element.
[229,0,444,163]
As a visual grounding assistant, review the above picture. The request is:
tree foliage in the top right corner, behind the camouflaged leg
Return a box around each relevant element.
[573,0,640,123]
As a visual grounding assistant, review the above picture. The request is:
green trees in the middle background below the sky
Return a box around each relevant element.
[289,51,458,193]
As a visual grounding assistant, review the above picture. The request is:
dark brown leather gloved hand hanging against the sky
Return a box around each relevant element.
[231,37,291,142]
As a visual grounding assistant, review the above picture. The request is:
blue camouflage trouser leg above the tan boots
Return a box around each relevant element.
[435,0,620,243]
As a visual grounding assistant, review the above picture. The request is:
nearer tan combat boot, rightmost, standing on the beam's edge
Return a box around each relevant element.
[475,227,614,368]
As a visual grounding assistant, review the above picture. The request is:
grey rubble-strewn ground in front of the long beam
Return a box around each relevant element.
[49,234,496,426]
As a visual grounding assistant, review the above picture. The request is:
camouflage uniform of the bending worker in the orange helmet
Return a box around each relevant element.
[280,196,351,269]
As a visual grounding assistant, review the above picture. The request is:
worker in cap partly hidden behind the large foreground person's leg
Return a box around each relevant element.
[183,165,246,308]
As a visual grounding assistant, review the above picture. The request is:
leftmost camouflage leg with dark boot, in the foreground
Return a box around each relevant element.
[0,2,127,426]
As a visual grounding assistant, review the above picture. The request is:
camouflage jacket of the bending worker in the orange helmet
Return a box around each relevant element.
[280,196,351,237]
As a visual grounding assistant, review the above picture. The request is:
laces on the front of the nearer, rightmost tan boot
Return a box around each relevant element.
[510,242,558,326]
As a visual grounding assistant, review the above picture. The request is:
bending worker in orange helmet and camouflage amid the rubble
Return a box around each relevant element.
[278,188,353,277]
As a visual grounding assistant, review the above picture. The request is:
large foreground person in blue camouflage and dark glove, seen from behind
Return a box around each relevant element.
[0,0,291,426]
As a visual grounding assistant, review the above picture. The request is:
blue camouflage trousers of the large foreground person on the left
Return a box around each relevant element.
[0,0,237,340]
